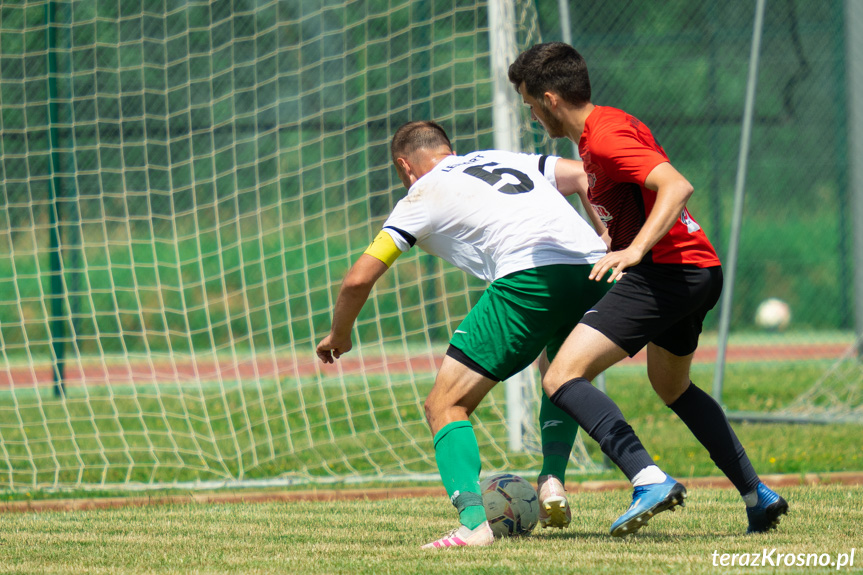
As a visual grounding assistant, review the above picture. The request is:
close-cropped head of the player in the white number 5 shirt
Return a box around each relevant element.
[390,121,453,188]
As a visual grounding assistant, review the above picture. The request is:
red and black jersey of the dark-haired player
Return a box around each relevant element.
[578,106,720,268]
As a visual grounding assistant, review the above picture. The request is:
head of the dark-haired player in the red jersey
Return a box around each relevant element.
[509,42,590,138]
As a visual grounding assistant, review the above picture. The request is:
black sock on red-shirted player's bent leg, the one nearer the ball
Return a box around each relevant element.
[551,377,654,481]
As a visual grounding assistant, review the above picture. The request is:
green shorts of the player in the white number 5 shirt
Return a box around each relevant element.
[450,265,608,381]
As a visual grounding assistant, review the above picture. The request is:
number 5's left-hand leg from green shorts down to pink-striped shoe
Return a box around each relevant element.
[426,266,554,547]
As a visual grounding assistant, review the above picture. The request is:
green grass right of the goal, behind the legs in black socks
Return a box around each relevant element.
[600,361,863,477]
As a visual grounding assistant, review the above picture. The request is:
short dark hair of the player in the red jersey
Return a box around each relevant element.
[509,42,590,106]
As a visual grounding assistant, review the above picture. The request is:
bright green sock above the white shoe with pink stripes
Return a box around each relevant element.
[434,421,485,529]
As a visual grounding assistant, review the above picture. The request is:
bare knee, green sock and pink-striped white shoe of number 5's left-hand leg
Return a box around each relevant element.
[424,355,497,548]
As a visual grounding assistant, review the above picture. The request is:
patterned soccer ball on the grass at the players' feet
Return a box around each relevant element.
[480,473,539,537]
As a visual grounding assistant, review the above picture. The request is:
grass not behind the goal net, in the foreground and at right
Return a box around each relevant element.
[0,361,863,575]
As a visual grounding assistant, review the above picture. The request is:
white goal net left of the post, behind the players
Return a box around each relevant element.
[0,0,594,496]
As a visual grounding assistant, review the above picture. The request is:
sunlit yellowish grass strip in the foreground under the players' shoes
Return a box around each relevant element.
[0,486,863,575]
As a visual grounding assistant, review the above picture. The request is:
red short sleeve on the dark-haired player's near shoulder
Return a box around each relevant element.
[591,123,668,186]
